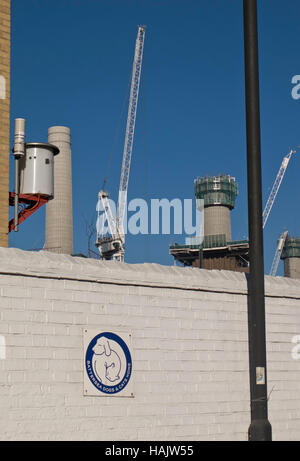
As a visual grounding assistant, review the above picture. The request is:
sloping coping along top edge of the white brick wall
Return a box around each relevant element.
[0,248,300,299]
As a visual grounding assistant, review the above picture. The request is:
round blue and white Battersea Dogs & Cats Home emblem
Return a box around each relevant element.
[85,332,132,395]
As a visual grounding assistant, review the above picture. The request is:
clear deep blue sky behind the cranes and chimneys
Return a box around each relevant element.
[10,0,300,275]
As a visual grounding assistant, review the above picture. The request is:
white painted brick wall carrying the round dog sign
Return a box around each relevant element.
[0,248,300,441]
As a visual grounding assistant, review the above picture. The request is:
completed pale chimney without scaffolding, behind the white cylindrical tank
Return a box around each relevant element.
[44,126,73,255]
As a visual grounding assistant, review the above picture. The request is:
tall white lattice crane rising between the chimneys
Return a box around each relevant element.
[95,26,145,262]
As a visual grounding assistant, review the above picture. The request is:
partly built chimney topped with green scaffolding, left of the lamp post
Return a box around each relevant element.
[194,175,238,244]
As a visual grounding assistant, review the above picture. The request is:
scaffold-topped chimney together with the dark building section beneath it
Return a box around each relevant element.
[169,175,249,272]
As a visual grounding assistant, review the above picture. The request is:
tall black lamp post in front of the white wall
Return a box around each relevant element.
[244,0,272,441]
